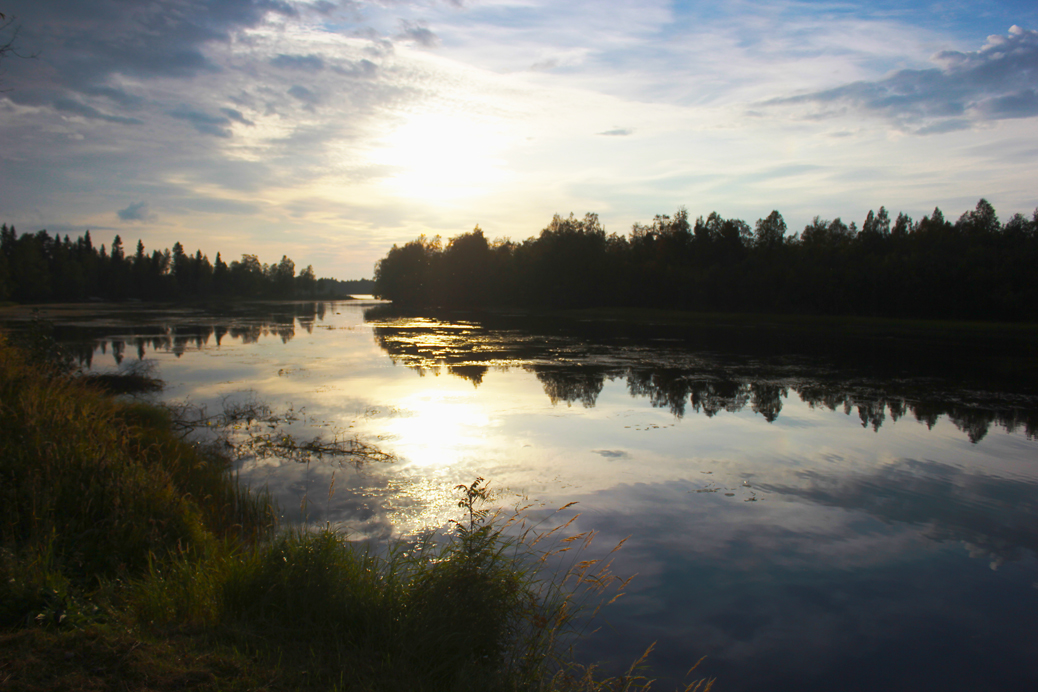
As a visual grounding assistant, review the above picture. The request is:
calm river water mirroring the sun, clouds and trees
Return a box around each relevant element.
[2,302,1038,690]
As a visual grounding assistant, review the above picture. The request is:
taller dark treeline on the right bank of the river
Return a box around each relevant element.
[375,199,1038,321]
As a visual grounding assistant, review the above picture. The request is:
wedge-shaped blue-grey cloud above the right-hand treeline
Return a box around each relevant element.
[762,26,1038,134]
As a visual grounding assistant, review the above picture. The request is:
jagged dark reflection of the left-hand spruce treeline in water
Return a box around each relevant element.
[70,303,326,367]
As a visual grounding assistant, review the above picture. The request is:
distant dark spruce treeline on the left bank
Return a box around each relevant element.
[0,224,363,303]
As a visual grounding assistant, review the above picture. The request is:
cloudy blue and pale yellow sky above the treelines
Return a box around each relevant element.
[0,0,1038,279]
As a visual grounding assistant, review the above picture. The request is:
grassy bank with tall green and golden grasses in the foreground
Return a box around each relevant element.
[0,336,697,691]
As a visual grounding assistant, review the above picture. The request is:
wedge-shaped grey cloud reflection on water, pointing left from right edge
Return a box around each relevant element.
[758,460,1038,568]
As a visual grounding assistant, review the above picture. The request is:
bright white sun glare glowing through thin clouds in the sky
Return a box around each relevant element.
[373,113,508,200]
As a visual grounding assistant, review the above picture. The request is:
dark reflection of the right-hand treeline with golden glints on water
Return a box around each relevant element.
[374,319,1038,442]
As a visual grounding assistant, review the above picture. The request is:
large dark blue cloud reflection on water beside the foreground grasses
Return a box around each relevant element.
[543,481,1038,690]
